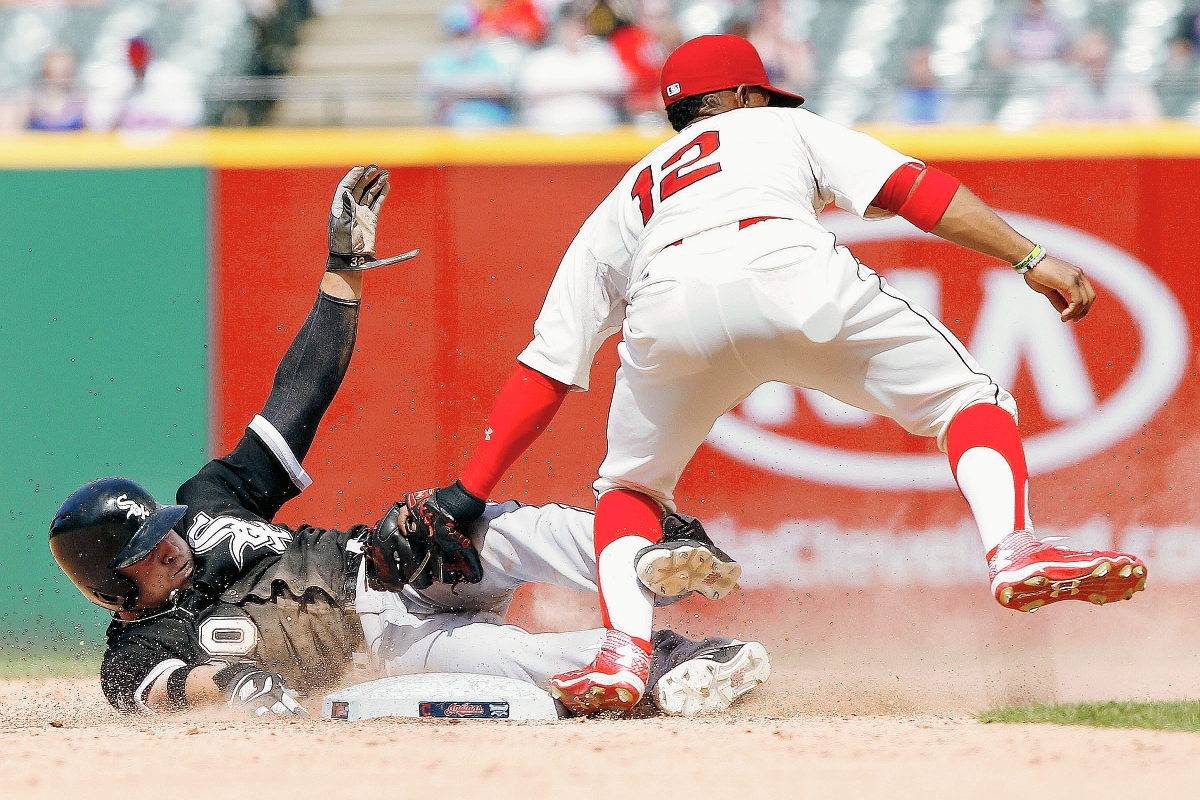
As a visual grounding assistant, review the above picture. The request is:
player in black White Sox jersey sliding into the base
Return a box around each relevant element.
[49,166,770,716]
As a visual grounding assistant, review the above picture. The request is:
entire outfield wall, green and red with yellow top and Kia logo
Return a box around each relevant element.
[0,126,1200,651]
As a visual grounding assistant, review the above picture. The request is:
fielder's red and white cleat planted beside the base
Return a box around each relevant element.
[550,631,650,714]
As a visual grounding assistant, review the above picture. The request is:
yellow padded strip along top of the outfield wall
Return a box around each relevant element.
[0,121,1200,169]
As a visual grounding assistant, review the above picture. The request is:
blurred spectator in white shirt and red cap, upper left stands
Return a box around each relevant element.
[86,37,204,131]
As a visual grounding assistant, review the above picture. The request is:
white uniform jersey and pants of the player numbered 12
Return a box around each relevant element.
[518,108,1016,513]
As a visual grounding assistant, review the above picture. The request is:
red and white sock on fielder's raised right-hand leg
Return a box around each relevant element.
[946,403,1030,560]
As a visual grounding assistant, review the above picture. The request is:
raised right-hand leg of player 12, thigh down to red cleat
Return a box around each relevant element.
[744,254,1146,612]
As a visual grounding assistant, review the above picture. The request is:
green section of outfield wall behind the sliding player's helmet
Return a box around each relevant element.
[0,167,209,660]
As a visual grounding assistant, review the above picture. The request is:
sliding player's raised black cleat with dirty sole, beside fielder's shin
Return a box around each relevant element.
[634,513,742,600]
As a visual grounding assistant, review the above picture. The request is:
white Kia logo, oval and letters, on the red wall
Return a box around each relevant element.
[707,212,1189,491]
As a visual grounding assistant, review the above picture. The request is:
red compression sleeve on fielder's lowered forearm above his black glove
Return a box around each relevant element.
[458,362,571,500]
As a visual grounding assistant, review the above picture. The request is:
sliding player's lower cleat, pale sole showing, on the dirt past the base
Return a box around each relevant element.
[649,631,770,716]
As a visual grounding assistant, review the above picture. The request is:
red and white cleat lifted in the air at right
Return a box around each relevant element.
[988,530,1146,612]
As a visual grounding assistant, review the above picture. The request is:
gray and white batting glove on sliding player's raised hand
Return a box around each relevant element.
[325,164,421,272]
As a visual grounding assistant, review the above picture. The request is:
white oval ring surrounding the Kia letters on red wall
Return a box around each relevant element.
[707,212,1189,491]
